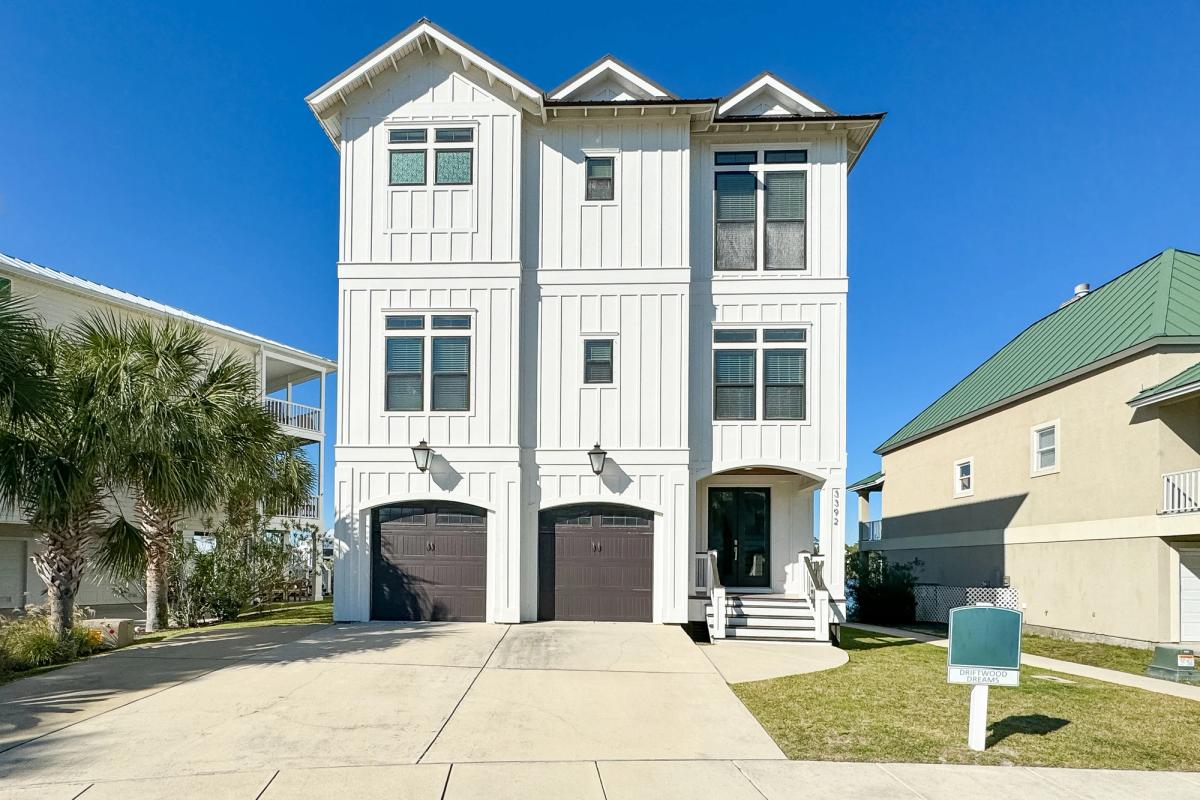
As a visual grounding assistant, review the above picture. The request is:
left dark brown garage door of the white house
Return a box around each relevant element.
[371,501,487,622]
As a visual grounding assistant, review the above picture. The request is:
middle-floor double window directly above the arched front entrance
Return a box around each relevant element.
[713,326,809,421]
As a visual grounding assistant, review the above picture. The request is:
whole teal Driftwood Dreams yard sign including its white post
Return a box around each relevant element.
[946,603,1021,750]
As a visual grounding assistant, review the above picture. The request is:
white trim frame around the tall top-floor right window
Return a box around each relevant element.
[708,142,816,278]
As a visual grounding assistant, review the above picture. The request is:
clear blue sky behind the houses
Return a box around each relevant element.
[0,1,1200,534]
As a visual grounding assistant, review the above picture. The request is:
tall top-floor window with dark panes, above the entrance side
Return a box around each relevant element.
[713,150,808,271]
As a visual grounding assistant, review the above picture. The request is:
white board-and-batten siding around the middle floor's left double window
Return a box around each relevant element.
[338,277,518,447]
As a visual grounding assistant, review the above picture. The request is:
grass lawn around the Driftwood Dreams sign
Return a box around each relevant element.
[733,627,1200,770]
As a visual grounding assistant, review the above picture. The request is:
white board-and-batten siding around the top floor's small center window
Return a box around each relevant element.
[523,115,690,270]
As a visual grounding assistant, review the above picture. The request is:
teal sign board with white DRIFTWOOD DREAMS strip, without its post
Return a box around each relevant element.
[947,606,1021,685]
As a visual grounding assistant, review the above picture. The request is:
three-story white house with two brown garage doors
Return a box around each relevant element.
[307,19,883,640]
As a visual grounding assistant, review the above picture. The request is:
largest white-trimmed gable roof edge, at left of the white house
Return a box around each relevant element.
[305,17,542,146]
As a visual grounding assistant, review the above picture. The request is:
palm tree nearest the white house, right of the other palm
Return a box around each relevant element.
[77,315,258,631]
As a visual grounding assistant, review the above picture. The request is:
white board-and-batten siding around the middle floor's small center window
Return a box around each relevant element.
[536,284,688,450]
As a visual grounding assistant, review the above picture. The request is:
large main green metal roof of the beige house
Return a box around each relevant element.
[875,248,1200,453]
